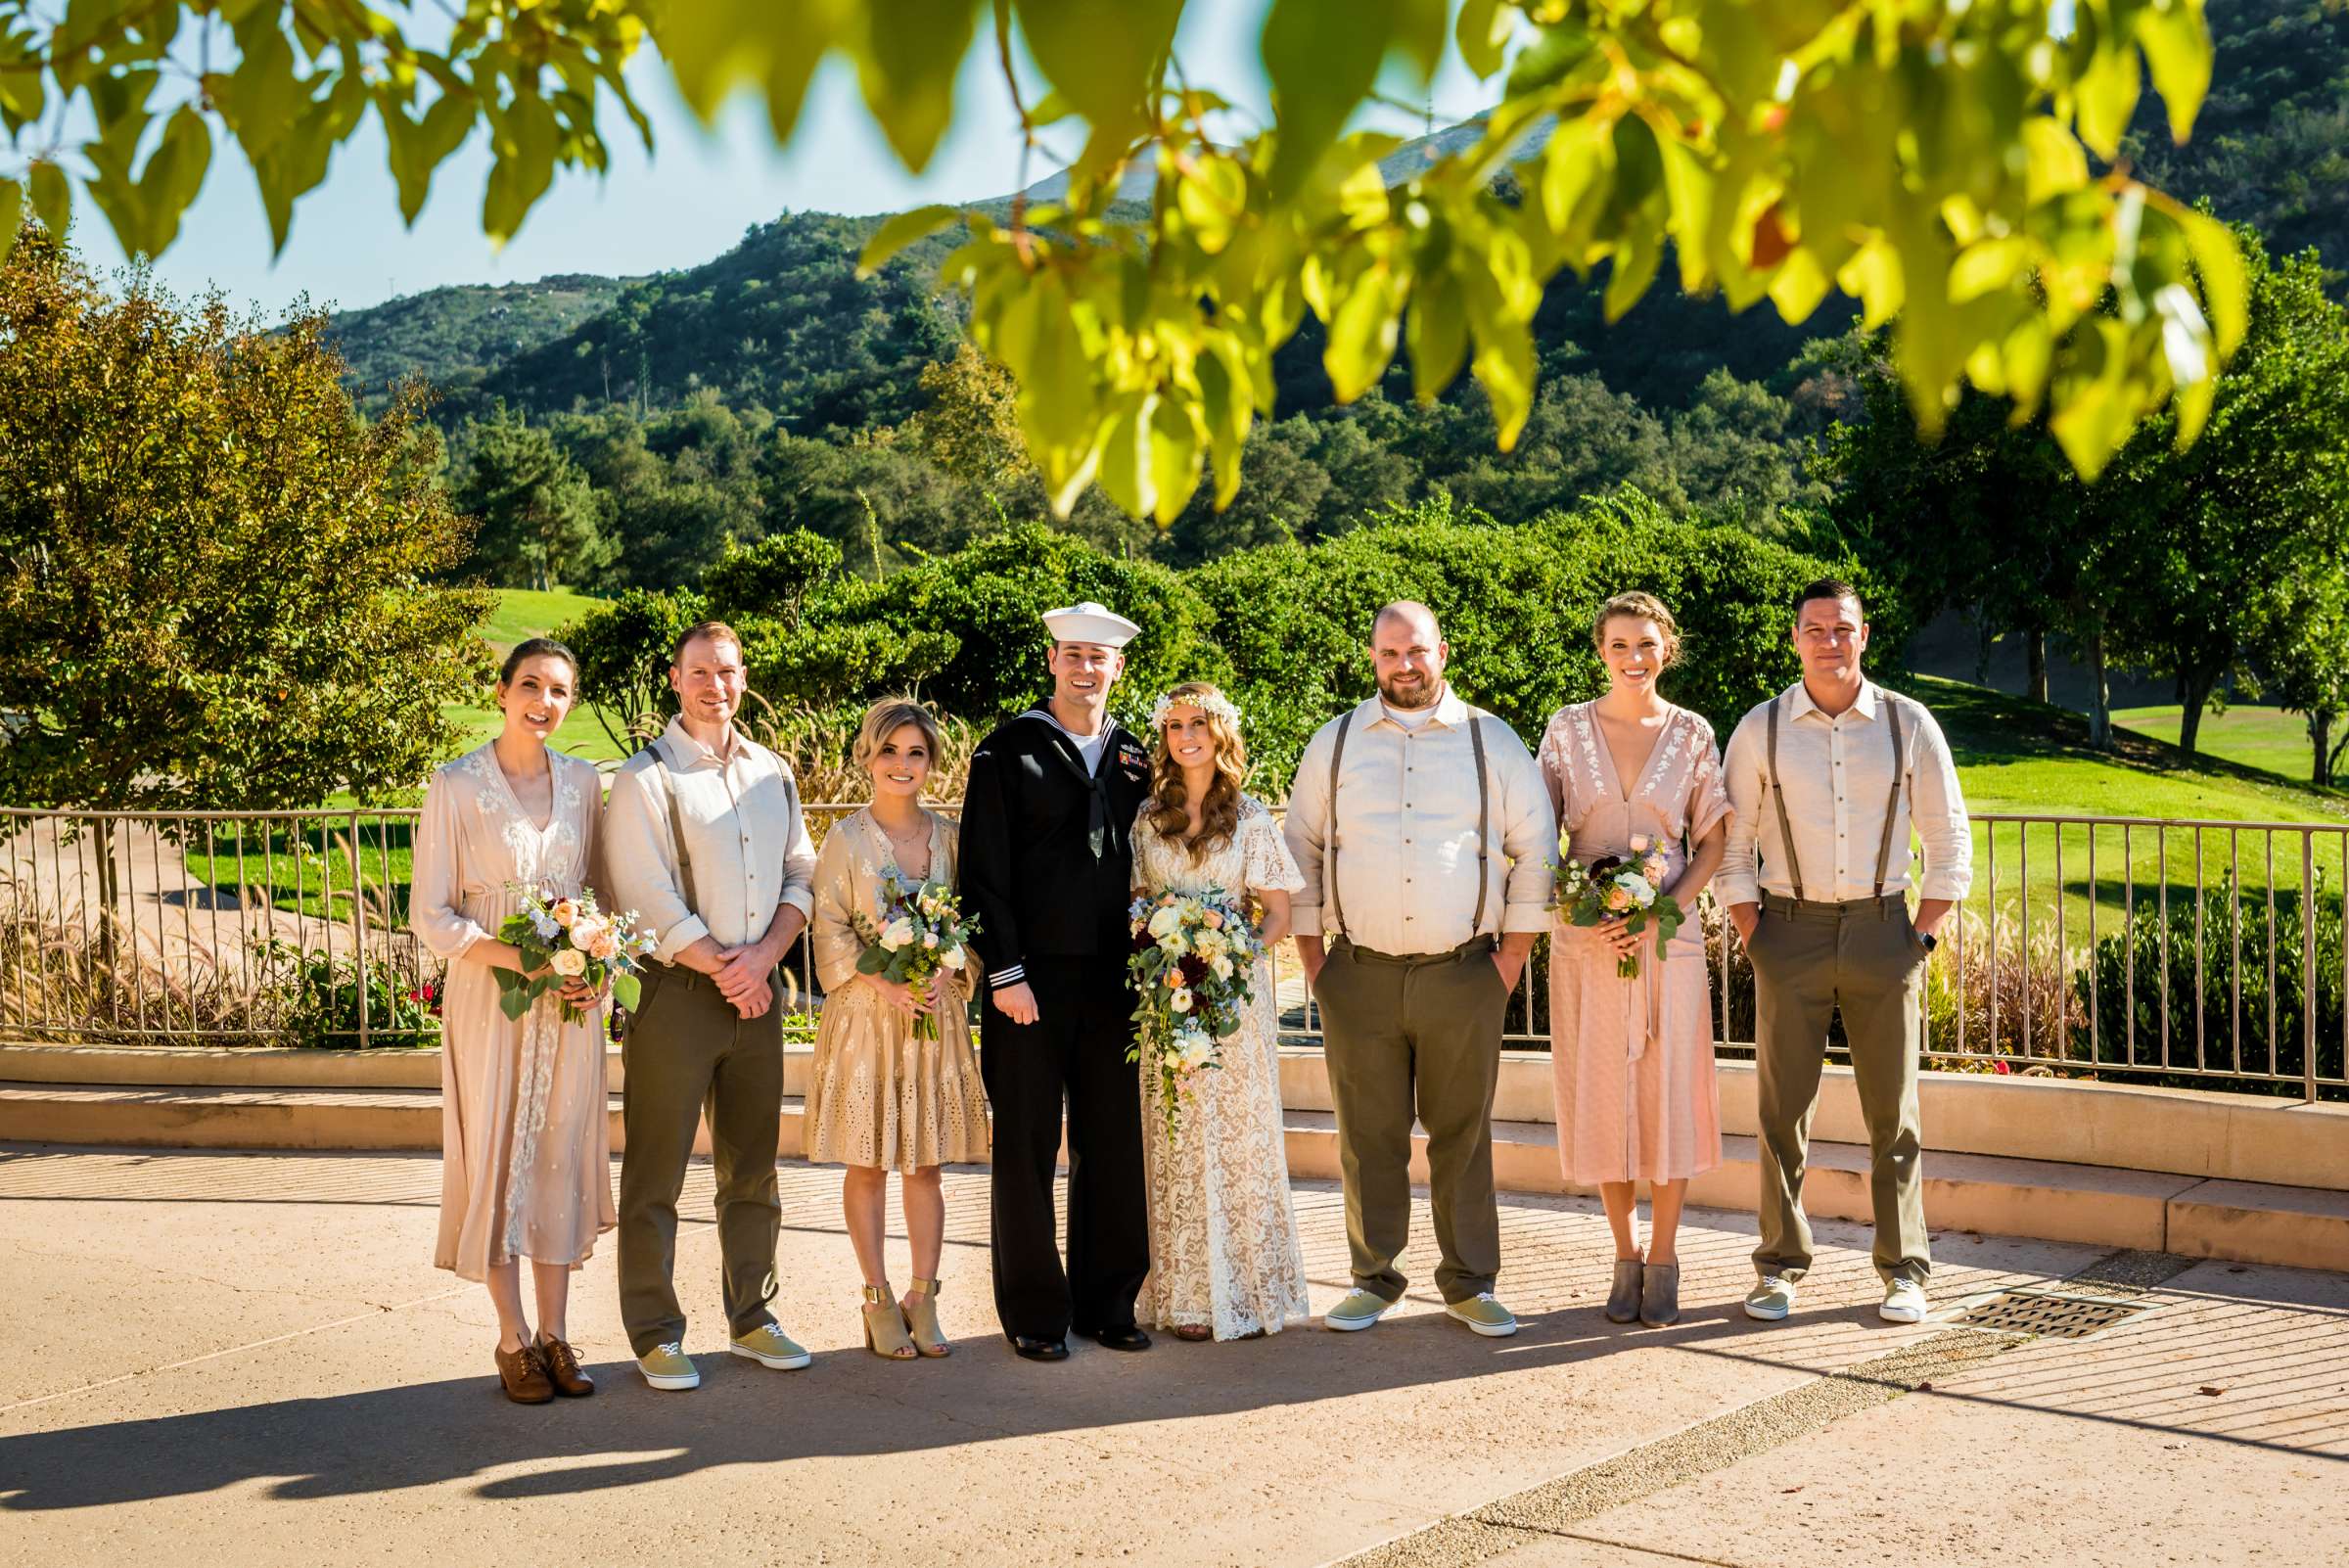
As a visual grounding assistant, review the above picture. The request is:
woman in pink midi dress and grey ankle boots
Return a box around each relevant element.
[1539,594,1728,1326]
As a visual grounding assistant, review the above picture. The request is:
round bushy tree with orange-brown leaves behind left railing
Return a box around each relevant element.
[0,232,493,809]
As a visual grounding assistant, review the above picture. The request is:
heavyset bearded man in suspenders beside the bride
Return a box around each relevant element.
[1285,603,1557,1336]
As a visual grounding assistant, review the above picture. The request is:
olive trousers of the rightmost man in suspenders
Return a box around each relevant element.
[1748,895,1933,1284]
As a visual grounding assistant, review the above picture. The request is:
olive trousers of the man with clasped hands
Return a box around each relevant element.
[621,965,782,1357]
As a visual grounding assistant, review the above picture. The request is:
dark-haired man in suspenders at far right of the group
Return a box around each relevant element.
[1715,577,1973,1324]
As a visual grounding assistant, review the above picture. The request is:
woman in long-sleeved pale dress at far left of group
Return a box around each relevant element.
[409,638,613,1404]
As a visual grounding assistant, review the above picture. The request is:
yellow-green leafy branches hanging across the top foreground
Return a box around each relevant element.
[0,0,2245,509]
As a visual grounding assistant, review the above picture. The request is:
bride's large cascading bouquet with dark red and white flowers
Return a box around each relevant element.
[1126,888,1264,1138]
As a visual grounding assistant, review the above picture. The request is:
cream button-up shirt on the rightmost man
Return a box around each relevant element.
[1715,680,1973,903]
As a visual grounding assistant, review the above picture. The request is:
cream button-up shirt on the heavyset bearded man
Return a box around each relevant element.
[1285,688,1557,955]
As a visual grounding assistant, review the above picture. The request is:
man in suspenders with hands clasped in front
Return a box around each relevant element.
[604,623,815,1390]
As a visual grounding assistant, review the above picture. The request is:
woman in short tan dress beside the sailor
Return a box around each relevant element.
[806,700,987,1361]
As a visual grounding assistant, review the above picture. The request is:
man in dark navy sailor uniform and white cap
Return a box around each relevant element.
[961,601,1151,1361]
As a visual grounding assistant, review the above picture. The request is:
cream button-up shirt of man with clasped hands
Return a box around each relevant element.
[604,718,815,962]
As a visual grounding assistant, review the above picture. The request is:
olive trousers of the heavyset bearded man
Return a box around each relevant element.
[1313,937,1508,1303]
